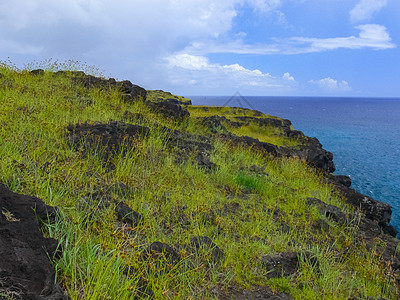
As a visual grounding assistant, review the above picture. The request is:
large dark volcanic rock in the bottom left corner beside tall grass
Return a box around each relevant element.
[0,184,68,300]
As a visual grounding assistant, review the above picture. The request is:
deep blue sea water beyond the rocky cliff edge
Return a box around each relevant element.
[189,96,400,231]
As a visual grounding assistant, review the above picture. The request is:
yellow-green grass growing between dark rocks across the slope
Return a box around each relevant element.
[0,63,398,299]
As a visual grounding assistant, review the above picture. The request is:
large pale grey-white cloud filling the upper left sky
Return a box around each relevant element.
[0,0,242,59]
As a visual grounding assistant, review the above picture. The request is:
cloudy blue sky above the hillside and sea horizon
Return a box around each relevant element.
[0,0,400,97]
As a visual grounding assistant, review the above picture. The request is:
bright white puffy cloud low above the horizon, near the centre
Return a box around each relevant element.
[166,54,297,94]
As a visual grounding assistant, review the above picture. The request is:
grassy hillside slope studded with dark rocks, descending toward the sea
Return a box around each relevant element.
[0,65,400,299]
